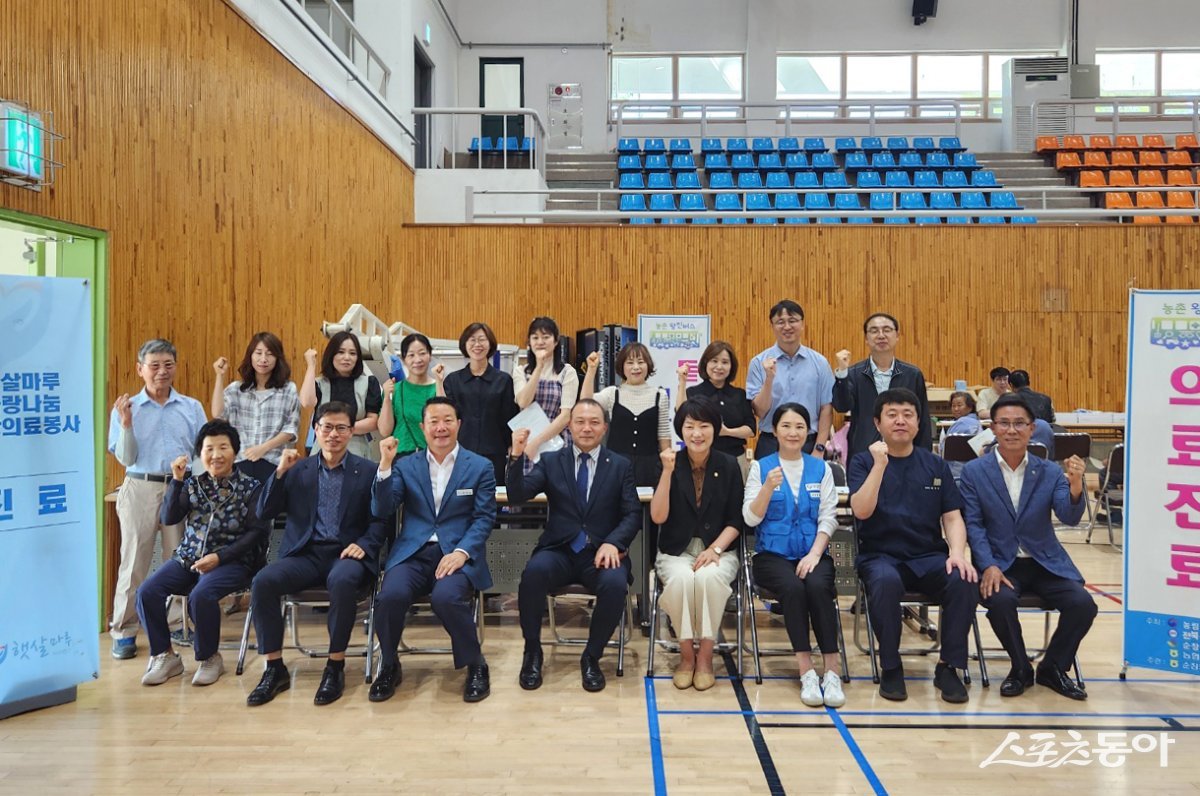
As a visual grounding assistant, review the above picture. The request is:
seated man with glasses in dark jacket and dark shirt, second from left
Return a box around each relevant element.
[246,401,386,706]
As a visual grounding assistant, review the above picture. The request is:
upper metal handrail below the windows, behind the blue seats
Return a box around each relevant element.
[608,98,964,139]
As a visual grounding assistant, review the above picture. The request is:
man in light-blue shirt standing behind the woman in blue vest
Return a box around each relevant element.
[746,299,833,460]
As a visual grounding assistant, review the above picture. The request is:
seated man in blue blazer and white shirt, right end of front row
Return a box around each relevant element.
[961,394,1096,700]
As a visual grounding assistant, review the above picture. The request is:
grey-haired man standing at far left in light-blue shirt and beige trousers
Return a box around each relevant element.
[108,340,208,659]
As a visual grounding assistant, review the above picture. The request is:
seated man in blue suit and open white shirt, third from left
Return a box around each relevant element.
[370,396,496,702]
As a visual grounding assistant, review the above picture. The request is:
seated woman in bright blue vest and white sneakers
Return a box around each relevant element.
[742,403,846,707]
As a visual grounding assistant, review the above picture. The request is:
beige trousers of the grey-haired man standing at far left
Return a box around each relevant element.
[109,478,184,639]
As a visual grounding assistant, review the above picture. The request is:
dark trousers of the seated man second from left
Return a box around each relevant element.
[250,541,371,654]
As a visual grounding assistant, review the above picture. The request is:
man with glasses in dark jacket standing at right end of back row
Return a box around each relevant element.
[833,312,934,462]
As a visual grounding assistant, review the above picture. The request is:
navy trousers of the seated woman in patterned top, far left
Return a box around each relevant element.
[138,558,254,660]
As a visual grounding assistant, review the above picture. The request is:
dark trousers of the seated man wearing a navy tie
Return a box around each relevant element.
[517,544,629,658]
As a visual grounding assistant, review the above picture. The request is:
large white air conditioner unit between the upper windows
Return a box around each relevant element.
[1003,58,1075,152]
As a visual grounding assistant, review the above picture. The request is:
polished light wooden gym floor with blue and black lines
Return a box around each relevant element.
[0,532,1200,795]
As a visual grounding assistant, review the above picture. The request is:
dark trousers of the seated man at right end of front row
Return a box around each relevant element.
[983,558,1096,671]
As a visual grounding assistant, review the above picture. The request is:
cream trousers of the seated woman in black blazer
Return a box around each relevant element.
[654,538,738,639]
